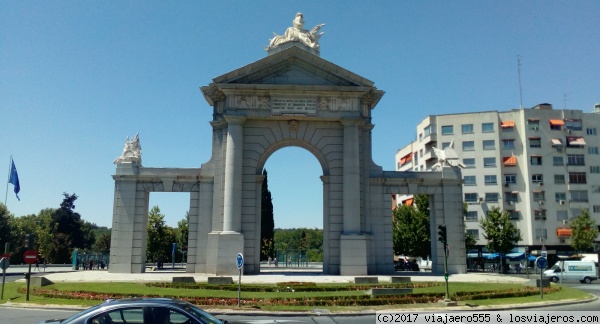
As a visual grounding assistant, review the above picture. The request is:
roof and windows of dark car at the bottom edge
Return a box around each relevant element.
[42,298,227,324]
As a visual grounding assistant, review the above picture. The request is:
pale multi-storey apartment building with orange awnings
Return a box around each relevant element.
[396,104,600,255]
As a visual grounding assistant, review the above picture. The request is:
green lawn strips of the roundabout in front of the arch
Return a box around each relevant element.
[1,282,590,312]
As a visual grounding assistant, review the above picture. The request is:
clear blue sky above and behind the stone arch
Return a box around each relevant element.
[0,0,600,228]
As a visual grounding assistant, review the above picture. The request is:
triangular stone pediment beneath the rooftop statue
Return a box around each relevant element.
[213,47,373,87]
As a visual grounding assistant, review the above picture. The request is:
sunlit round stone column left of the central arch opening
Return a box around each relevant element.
[223,116,246,232]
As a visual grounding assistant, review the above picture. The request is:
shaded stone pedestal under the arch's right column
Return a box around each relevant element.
[340,234,370,276]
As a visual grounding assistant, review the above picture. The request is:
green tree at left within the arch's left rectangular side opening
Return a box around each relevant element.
[146,206,173,262]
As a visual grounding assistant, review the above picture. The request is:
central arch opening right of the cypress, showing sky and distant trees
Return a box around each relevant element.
[261,147,324,272]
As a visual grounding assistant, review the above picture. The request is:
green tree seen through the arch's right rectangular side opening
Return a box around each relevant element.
[392,195,431,257]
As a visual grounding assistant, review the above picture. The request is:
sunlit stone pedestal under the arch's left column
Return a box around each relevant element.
[206,232,244,276]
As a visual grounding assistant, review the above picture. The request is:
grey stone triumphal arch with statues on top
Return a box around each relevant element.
[109,14,466,275]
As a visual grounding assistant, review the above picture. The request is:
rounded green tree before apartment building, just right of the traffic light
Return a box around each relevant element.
[479,207,521,270]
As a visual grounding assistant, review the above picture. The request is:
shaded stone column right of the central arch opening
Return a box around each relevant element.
[342,121,361,234]
